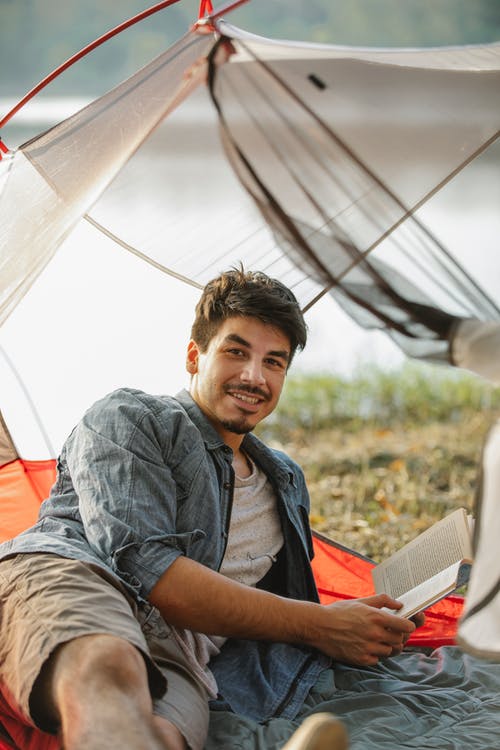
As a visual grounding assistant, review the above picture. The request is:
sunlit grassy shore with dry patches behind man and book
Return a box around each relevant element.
[260,365,500,561]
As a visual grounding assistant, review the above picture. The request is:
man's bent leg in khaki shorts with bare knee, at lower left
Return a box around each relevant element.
[0,554,191,750]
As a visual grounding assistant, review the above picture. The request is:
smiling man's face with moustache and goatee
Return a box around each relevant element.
[187,316,290,447]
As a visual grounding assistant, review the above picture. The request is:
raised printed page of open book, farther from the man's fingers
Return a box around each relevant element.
[372,508,472,599]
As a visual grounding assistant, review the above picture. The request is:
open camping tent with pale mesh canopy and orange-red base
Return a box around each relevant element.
[0,2,500,748]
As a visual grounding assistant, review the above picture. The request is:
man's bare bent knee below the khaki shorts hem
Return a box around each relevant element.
[31,635,186,750]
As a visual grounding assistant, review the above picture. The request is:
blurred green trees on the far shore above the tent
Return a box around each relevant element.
[0,0,500,96]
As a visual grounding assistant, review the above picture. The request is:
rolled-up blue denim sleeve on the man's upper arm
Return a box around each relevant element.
[66,390,204,598]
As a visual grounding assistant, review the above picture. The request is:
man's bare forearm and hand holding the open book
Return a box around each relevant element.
[149,557,415,665]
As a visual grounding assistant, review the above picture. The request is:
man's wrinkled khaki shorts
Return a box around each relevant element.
[0,553,208,750]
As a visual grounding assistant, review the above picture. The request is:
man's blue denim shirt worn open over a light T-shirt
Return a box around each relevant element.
[0,389,328,721]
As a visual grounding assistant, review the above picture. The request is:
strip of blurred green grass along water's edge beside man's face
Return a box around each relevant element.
[265,363,500,436]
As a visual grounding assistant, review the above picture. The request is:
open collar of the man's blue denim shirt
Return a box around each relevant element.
[175,388,294,490]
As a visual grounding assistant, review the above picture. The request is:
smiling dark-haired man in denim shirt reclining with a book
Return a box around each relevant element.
[0,270,415,750]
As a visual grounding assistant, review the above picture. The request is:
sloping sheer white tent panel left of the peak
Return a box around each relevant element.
[0,27,213,324]
